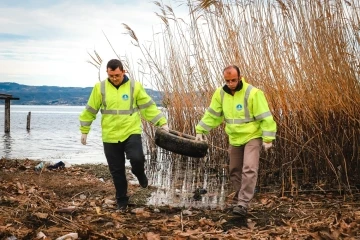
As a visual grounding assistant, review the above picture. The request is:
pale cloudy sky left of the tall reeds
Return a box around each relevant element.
[0,0,186,87]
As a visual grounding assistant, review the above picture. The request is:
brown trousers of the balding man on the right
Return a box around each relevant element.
[229,138,262,208]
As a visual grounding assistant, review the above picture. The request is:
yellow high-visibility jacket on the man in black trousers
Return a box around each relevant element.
[79,76,167,143]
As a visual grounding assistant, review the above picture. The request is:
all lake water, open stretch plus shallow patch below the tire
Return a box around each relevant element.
[0,105,228,207]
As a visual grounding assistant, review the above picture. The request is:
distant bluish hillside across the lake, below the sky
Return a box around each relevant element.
[0,82,162,106]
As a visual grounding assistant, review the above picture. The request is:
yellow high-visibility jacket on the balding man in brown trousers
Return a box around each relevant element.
[195,78,276,146]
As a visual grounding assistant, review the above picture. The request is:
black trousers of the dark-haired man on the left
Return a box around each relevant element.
[104,134,145,204]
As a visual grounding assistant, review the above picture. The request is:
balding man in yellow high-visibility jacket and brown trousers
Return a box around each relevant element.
[195,65,276,216]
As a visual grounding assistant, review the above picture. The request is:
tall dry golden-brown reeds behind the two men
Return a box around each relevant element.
[96,0,360,194]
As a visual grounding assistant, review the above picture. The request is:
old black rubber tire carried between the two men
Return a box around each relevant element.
[155,128,209,158]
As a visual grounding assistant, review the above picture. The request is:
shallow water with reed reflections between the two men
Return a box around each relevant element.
[147,152,229,208]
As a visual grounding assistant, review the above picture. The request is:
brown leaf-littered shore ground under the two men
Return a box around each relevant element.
[0,159,360,240]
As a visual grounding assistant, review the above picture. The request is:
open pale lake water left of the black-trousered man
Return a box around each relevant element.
[0,105,106,164]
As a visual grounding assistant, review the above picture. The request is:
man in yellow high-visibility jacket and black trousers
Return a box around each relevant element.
[79,59,169,210]
